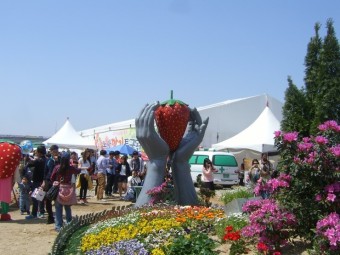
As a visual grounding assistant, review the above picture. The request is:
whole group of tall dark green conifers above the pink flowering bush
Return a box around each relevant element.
[281,19,340,135]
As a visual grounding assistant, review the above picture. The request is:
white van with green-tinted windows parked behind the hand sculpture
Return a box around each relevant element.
[189,151,239,186]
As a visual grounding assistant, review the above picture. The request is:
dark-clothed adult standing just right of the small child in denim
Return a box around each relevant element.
[26,145,46,220]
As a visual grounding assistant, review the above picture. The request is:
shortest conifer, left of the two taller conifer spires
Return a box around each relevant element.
[281,77,309,136]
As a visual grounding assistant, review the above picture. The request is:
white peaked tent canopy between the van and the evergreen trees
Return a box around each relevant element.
[212,106,280,152]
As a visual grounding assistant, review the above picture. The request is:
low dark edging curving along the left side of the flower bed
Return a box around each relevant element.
[50,204,133,255]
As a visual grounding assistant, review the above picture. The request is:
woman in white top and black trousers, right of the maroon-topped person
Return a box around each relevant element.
[78,149,92,204]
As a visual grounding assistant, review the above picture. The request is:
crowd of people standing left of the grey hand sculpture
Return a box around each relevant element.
[18,145,146,231]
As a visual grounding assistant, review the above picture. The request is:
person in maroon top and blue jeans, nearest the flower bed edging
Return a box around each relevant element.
[51,152,80,232]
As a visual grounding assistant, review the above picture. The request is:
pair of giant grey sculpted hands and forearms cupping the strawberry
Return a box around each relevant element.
[135,102,209,206]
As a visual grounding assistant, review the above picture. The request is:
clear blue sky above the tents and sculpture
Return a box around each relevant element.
[0,0,340,136]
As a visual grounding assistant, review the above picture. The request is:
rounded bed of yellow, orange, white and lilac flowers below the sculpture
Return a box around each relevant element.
[64,205,226,255]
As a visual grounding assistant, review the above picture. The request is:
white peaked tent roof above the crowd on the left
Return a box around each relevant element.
[44,119,96,149]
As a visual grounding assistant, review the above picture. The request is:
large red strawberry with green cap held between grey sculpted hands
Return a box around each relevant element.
[155,91,190,152]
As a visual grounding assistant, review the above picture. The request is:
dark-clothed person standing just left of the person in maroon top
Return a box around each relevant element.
[41,144,60,224]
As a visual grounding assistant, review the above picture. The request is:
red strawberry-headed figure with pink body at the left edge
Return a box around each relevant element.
[0,142,21,221]
